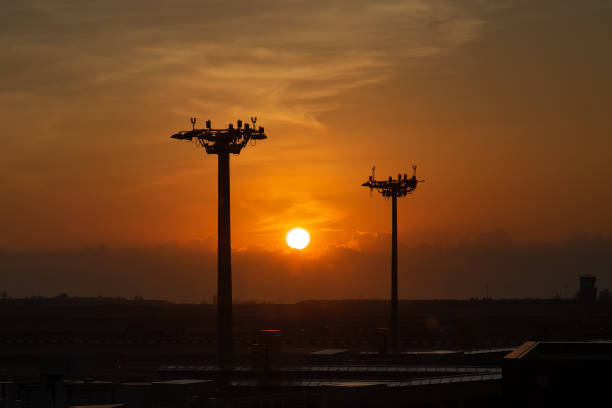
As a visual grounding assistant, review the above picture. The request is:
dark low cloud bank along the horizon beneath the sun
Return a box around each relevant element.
[0,233,612,302]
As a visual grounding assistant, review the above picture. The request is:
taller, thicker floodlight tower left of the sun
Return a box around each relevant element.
[170,118,267,368]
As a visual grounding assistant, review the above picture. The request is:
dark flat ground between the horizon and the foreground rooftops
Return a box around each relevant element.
[0,298,612,380]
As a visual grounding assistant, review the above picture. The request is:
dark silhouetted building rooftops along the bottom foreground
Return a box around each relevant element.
[0,342,612,408]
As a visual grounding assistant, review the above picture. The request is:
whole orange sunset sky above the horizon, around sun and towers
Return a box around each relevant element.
[0,0,612,301]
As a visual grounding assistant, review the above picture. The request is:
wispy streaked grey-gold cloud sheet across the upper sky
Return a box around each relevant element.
[0,0,483,131]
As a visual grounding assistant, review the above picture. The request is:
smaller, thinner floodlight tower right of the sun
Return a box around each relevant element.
[362,166,425,352]
